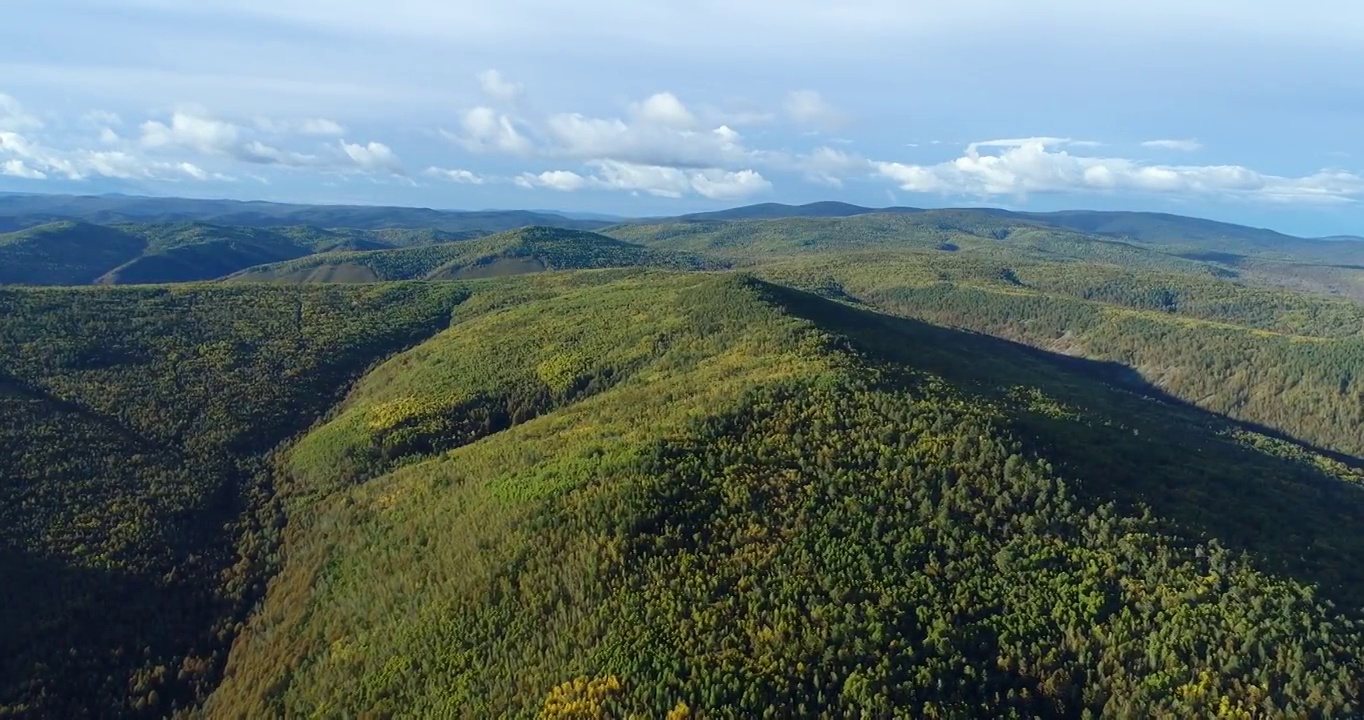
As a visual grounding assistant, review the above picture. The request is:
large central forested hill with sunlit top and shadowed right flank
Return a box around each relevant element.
[207,274,1364,717]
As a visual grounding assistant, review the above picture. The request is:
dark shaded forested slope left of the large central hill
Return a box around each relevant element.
[0,279,461,717]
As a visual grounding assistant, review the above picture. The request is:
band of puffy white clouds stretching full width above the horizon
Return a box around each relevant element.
[0,82,1364,206]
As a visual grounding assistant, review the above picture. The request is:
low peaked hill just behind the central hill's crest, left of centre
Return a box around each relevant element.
[228,228,722,282]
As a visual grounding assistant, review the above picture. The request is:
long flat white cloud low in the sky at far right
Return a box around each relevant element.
[873,138,1364,203]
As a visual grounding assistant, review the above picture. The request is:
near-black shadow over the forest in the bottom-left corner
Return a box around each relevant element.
[0,547,228,719]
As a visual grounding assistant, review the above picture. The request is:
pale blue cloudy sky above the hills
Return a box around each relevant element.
[0,0,1364,236]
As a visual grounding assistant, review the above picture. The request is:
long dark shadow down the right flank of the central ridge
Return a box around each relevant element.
[767,280,1364,611]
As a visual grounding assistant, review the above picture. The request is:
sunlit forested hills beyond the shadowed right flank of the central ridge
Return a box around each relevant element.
[607,214,1364,457]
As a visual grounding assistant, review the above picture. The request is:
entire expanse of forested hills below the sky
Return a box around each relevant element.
[0,199,1364,717]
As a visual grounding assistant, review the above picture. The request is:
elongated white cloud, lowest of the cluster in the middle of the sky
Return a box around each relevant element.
[516,160,772,200]
